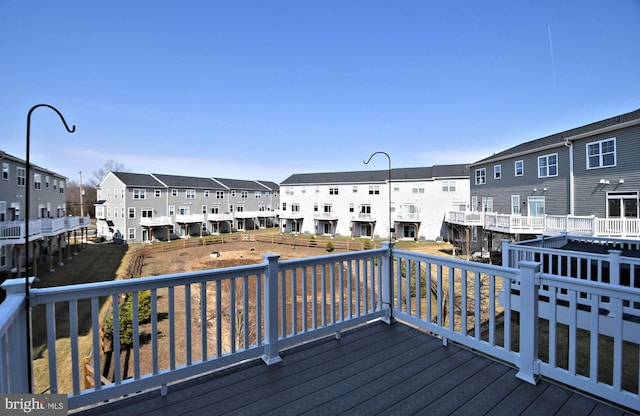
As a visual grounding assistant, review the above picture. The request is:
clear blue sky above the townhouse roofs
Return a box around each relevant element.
[0,0,640,182]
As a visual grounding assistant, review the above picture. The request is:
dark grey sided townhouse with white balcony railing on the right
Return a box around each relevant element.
[448,110,640,254]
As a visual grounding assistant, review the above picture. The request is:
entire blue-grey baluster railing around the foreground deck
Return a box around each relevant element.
[0,243,640,410]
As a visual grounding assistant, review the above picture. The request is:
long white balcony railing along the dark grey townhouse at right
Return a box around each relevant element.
[446,211,640,238]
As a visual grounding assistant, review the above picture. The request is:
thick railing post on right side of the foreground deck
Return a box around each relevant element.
[516,261,540,384]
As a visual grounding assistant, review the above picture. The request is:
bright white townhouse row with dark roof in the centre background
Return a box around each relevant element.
[280,165,469,240]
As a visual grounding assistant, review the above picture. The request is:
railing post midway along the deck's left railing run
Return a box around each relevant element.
[262,254,284,365]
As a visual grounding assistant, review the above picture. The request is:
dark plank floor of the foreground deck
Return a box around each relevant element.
[75,322,630,416]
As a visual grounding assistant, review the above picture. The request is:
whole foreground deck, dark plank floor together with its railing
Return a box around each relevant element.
[0,243,640,415]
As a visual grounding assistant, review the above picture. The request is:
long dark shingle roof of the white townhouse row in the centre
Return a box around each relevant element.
[280,165,469,186]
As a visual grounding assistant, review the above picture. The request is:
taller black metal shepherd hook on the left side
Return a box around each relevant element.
[24,104,76,393]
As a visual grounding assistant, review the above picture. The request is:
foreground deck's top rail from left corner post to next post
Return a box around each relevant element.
[30,262,266,306]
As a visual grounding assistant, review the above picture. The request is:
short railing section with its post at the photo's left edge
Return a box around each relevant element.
[0,277,35,394]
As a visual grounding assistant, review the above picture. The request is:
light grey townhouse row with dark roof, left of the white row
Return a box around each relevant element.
[95,172,278,243]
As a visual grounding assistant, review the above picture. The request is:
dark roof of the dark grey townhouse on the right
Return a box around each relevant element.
[471,109,640,166]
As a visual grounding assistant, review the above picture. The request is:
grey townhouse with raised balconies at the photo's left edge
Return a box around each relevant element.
[0,151,89,280]
